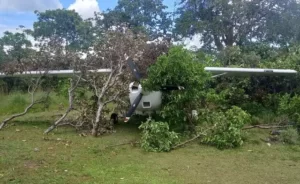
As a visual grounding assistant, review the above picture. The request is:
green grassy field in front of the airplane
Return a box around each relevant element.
[0,92,300,184]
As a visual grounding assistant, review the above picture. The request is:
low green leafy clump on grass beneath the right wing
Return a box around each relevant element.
[202,107,250,149]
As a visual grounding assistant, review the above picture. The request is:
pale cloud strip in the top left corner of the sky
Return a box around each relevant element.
[0,0,63,12]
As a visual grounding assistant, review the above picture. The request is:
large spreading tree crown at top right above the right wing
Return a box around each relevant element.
[176,0,300,51]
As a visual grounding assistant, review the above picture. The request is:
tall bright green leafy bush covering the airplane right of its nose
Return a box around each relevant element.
[142,47,209,128]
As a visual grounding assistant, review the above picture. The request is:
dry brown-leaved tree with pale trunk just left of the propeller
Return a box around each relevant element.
[85,26,146,136]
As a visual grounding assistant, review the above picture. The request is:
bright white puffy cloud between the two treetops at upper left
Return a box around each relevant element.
[68,0,100,19]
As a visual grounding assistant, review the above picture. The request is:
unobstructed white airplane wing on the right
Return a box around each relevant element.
[204,67,298,76]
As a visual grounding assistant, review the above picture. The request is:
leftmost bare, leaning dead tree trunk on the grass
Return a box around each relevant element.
[0,78,43,130]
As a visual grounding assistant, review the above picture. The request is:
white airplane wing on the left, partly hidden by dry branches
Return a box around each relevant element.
[0,69,111,78]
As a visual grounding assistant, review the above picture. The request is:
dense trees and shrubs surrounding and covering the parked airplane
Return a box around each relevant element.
[0,0,300,151]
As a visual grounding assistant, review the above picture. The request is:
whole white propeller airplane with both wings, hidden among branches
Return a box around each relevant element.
[0,59,298,122]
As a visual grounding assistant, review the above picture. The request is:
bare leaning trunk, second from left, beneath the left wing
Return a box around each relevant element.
[44,77,81,134]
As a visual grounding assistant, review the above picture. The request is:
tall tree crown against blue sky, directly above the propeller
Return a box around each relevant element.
[98,0,171,38]
